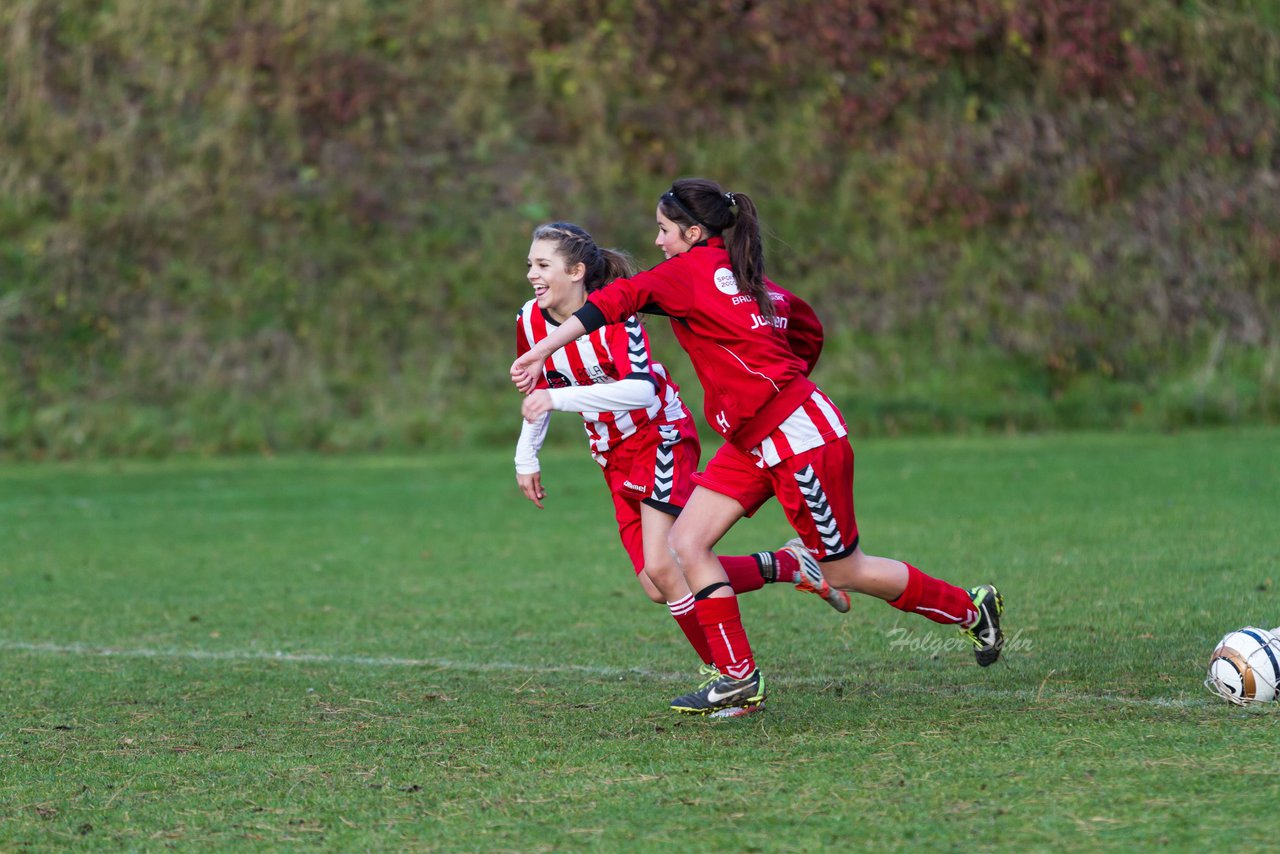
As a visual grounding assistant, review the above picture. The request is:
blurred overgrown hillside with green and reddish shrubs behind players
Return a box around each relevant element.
[0,0,1280,458]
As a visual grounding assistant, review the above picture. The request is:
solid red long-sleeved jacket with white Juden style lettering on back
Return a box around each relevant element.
[577,237,844,452]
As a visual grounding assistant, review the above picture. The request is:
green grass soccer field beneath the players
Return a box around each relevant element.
[0,430,1280,851]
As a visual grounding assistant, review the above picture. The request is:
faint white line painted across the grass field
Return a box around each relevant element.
[0,639,1226,709]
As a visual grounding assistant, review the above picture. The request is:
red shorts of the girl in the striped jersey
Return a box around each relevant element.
[604,417,703,575]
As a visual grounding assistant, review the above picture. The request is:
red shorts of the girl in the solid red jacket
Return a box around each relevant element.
[694,437,858,560]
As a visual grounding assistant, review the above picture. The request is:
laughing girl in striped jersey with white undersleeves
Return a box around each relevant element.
[516,223,849,696]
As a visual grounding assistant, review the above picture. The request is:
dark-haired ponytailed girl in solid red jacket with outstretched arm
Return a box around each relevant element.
[511,185,1004,714]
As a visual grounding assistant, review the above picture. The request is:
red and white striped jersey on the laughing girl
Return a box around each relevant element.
[516,300,691,466]
